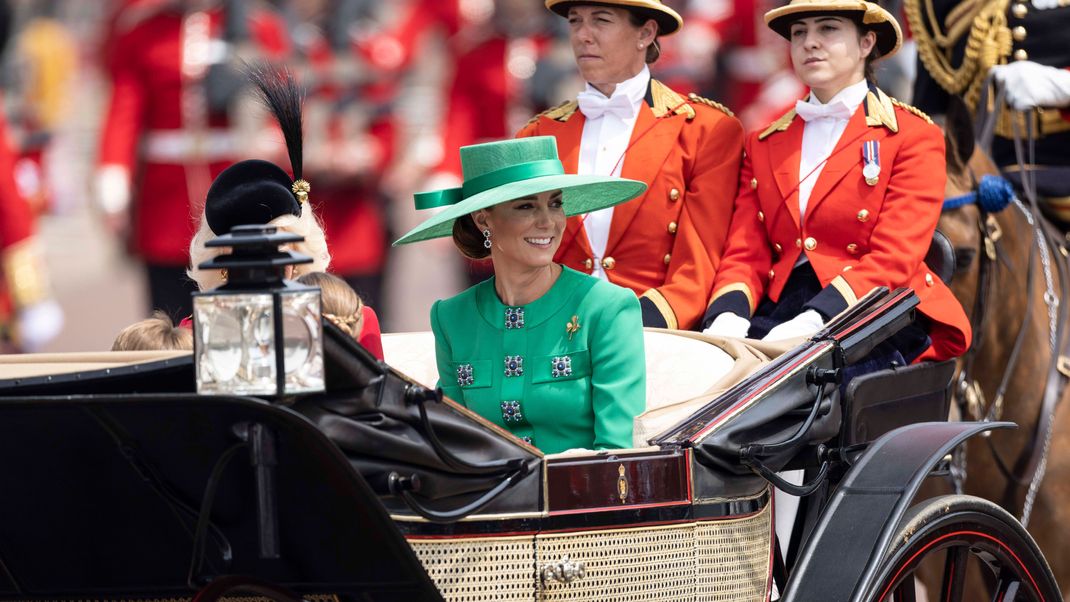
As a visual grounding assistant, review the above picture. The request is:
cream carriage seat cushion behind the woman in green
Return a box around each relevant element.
[383,328,735,419]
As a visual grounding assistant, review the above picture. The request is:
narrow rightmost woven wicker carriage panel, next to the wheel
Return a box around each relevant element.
[694,504,773,602]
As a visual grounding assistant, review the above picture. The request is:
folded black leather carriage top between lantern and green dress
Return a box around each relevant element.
[293,326,546,522]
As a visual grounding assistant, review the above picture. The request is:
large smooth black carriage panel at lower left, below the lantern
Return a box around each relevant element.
[0,393,437,600]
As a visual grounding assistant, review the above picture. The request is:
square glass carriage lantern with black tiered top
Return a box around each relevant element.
[194,226,324,398]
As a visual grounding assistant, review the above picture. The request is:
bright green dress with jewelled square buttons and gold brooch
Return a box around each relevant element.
[431,267,646,453]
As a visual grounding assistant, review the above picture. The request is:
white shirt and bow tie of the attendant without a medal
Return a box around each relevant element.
[576,65,651,280]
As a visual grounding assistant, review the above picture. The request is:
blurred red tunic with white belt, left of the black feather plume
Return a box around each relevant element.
[98,2,287,266]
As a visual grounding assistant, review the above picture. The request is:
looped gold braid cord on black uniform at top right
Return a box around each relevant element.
[903,0,1011,111]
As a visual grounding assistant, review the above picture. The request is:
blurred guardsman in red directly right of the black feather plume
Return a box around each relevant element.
[291,0,397,307]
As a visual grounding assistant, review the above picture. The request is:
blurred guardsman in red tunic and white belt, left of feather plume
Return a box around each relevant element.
[96,0,288,315]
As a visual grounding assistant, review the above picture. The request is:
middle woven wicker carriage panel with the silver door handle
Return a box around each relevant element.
[536,523,696,602]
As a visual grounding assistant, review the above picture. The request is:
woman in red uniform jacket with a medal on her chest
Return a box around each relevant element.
[704,0,970,361]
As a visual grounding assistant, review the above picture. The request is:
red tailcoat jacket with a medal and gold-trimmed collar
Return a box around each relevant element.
[707,88,970,359]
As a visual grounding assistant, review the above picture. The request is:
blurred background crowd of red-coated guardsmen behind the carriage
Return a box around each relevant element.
[0,0,915,351]
